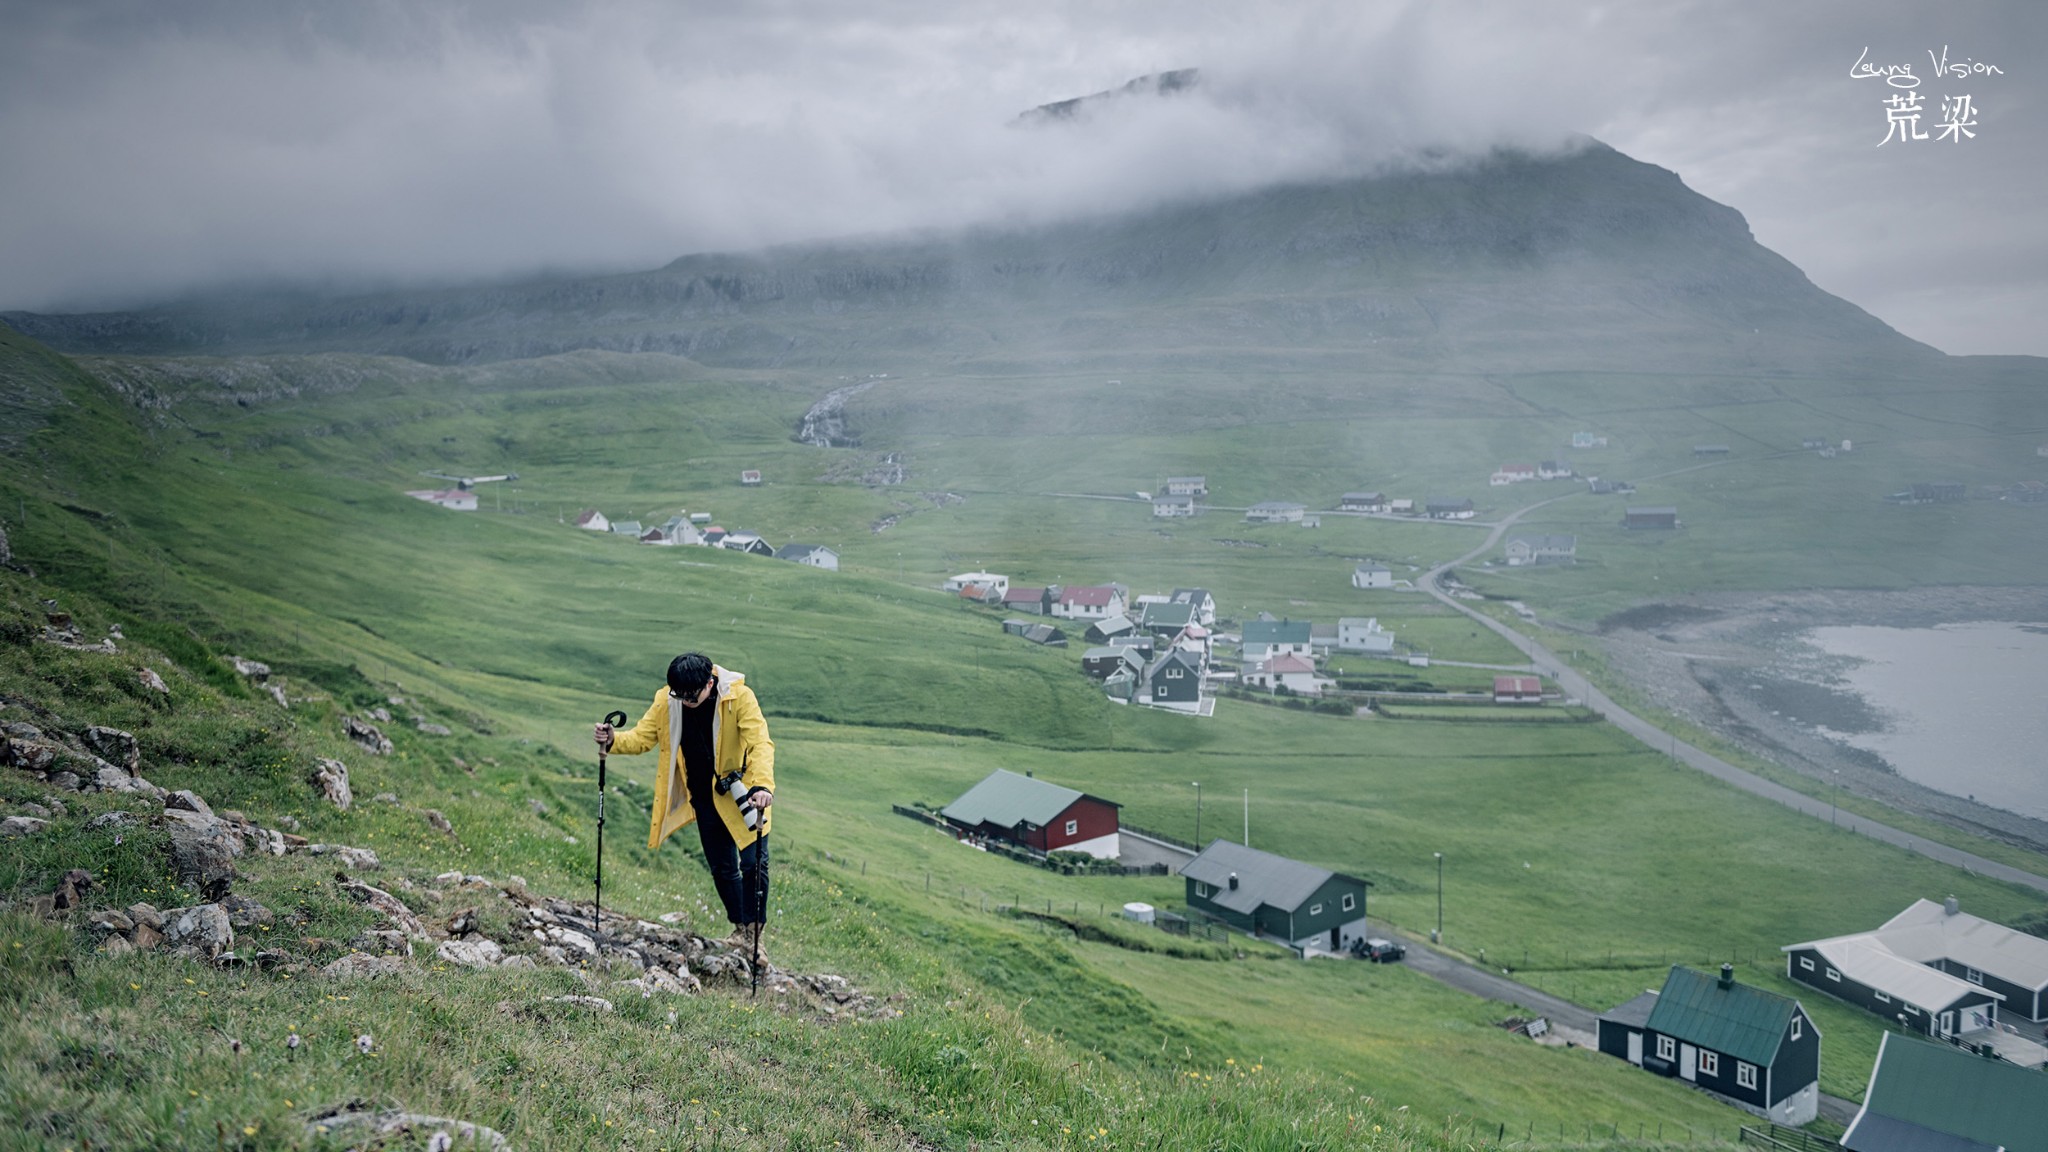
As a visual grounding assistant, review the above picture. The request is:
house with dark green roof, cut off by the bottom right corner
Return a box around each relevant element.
[1841,1031,2048,1152]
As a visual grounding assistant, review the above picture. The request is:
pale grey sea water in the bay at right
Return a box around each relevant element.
[1806,623,2048,820]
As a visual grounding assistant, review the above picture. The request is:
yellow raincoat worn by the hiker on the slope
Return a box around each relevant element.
[612,664,774,849]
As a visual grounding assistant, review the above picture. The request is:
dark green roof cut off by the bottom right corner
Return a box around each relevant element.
[1851,1033,2048,1152]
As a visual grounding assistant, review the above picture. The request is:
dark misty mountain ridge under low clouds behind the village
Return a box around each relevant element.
[4,141,1937,375]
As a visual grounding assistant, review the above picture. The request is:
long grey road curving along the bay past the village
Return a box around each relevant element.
[1417,492,2048,894]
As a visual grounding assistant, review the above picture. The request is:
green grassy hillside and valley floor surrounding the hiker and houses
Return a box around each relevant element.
[0,309,2048,1148]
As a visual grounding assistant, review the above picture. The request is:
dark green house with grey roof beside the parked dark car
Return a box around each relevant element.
[1180,840,1370,955]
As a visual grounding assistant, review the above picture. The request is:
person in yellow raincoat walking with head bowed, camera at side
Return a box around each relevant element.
[592,652,774,955]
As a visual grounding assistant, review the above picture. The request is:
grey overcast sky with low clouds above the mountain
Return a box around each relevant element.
[0,0,2048,355]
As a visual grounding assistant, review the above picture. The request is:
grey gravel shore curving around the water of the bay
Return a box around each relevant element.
[1599,588,2048,853]
